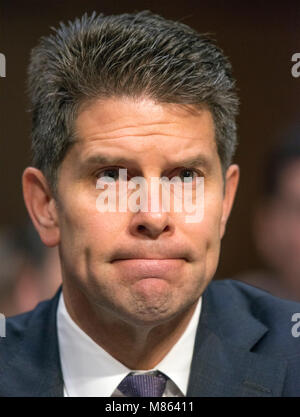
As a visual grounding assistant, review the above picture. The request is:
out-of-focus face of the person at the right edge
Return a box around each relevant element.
[255,158,300,281]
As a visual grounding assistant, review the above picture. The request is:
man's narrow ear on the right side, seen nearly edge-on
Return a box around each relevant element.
[220,164,240,239]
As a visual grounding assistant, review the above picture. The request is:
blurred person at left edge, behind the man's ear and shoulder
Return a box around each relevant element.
[0,222,61,316]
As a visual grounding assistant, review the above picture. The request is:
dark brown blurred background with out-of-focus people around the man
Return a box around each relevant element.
[0,0,300,315]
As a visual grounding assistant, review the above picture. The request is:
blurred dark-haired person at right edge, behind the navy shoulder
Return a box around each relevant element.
[237,123,300,301]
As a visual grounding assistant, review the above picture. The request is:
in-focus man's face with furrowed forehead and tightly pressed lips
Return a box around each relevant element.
[53,98,235,325]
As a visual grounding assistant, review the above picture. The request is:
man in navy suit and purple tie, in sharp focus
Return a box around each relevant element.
[0,12,300,397]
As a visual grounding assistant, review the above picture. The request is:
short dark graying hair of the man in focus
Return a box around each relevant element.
[28,11,239,188]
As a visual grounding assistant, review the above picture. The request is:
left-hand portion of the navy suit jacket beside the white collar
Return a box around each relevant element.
[0,289,61,396]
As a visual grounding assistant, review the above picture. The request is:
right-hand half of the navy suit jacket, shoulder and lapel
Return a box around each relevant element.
[189,280,300,397]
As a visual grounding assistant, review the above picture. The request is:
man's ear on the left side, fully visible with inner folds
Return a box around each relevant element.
[22,167,60,246]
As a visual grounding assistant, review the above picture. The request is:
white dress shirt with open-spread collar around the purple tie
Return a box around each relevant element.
[57,292,202,397]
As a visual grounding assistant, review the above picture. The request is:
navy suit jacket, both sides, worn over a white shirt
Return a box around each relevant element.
[0,280,300,397]
